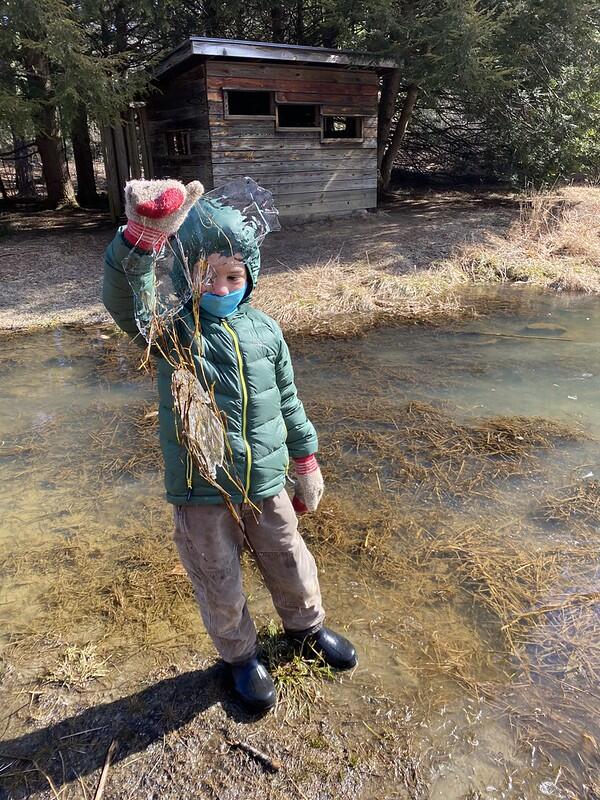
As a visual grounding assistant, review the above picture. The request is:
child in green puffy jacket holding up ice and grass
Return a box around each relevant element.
[103,180,356,710]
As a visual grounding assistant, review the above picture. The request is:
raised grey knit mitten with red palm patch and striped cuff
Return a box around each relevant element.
[123,180,204,250]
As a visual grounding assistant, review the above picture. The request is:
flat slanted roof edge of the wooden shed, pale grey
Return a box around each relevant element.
[154,36,397,76]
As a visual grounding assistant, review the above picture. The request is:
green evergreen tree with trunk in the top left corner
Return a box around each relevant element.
[0,0,140,206]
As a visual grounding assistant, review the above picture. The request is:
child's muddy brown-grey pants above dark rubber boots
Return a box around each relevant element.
[174,491,325,664]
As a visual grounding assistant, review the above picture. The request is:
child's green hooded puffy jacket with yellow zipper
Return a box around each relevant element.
[103,199,318,505]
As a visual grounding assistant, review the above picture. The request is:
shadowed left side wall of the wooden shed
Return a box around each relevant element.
[146,64,213,189]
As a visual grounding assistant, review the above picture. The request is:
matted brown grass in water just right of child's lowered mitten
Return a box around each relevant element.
[319,401,586,503]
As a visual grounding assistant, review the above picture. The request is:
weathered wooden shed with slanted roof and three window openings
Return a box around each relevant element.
[122,37,394,218]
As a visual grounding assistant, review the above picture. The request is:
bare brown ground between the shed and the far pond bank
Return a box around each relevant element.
[0,191,518,331]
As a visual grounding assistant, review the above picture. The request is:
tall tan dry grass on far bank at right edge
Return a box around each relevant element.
[454,187,600,293]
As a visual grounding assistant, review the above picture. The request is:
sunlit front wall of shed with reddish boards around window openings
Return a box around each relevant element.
[206,60,378,217]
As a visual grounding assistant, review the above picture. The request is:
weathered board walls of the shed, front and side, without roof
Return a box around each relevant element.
[146,58,379,217]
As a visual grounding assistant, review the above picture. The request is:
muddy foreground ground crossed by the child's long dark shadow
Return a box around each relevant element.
[0,648,424,800]
